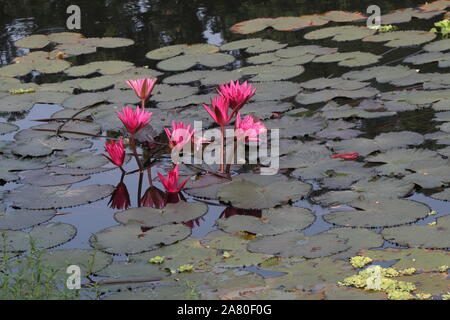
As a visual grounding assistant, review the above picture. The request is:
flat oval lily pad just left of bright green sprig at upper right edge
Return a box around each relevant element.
[363,30,436,47]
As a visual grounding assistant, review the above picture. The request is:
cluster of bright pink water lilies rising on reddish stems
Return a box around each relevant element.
[104,78,266,209]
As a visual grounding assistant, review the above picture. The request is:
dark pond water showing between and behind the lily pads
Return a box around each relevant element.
[0,0,450,300]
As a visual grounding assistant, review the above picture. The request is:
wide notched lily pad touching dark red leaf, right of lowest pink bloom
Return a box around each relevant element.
[217,206,315,236]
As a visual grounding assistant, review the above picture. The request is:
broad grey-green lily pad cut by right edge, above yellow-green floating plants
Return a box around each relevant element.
[382,216,450,249]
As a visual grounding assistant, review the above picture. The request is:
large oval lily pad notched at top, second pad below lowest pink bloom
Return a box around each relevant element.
[89,223,191,254]
